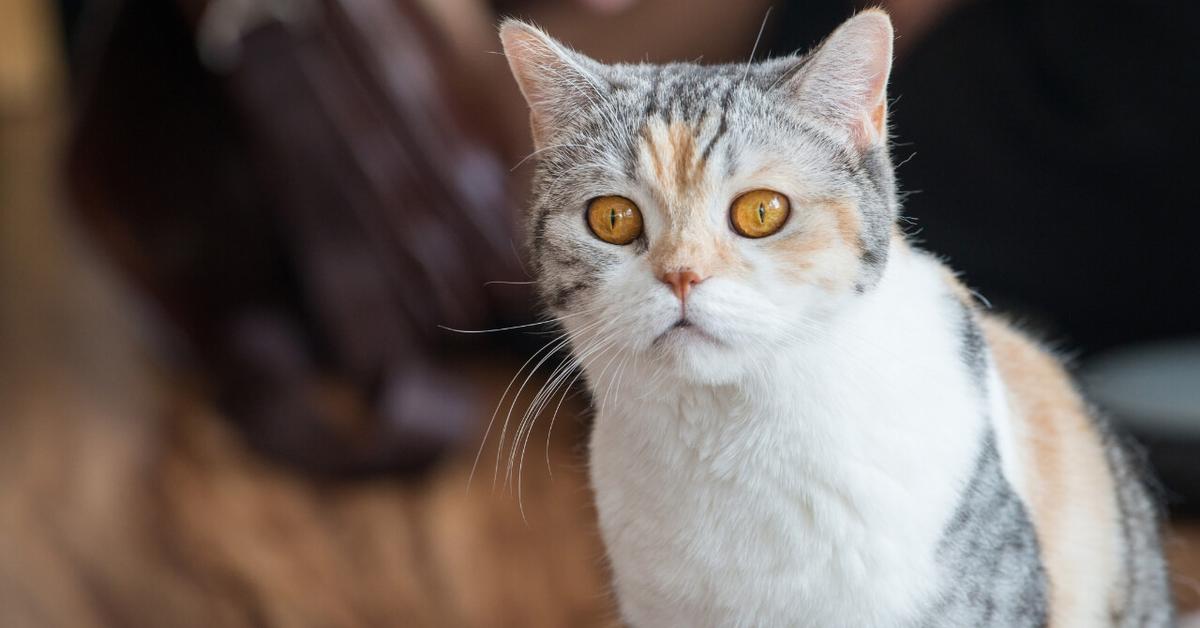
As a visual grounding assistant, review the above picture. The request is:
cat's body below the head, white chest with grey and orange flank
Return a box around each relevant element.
[592,242,1170,628]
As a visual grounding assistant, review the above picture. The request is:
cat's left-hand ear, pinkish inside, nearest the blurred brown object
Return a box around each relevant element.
[500,19,602,150]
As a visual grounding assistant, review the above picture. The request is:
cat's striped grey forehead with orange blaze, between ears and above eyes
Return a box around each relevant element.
[544,58,829,201]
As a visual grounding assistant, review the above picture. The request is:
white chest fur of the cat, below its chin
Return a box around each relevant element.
[589,257,986,627]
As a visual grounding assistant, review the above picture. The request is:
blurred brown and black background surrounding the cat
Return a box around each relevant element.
[0,0,1200,627]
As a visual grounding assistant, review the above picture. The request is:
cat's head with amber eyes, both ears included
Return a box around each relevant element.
[500,11,896,382]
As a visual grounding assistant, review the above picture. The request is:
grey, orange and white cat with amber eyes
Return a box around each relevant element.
[500,10,1174,628]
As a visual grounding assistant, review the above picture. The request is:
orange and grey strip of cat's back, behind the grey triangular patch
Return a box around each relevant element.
[978,315,1172,627]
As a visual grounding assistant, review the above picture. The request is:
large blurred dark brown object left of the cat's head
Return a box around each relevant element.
[70,0,528,472]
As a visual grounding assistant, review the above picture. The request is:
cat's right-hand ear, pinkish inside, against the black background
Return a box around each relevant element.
[786,8,893,149]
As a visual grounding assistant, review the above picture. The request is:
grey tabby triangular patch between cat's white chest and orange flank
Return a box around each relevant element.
[916,429,1048,628]
